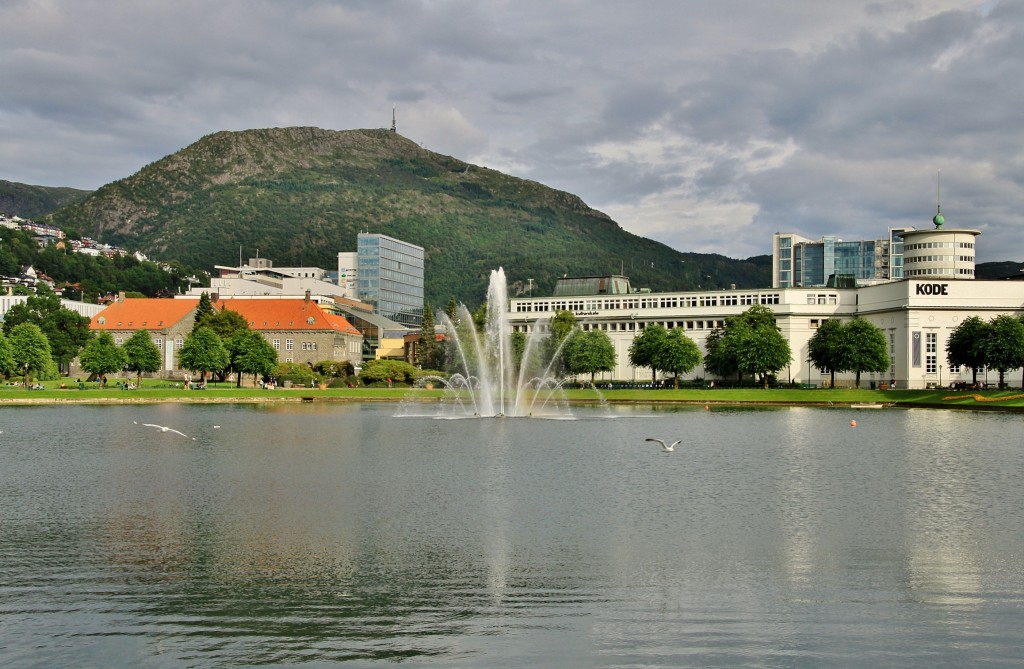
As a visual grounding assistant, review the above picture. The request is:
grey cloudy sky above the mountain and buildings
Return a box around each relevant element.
[0,0,1024,261]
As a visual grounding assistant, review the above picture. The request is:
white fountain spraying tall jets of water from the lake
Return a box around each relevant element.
[421,267,571,418]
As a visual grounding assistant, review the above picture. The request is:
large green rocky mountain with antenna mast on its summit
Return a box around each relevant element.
[49,128,771,306]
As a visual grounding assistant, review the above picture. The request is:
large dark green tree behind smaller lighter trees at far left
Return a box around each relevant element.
[4,284,92,372]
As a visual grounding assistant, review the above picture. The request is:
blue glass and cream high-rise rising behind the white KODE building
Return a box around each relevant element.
[772,227,909,288]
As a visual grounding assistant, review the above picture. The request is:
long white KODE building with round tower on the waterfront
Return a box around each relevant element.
[509,220,1024,388]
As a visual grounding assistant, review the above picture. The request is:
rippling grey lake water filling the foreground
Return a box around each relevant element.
[0,405,1024,668]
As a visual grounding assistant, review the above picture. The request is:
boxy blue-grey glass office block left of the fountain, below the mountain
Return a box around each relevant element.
[355,233,423,327]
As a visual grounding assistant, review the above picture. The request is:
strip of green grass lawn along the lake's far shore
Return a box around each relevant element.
[0,379,1024,411]
